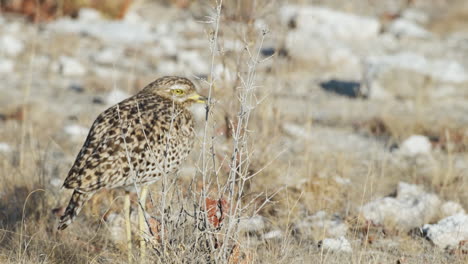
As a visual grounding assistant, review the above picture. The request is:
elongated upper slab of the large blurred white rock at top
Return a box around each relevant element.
[280,5,380,41]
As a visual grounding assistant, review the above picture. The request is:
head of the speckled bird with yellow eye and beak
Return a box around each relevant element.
[142,76,208,105]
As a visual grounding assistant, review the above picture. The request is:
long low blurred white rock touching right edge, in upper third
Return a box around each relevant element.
[367,52,468,83]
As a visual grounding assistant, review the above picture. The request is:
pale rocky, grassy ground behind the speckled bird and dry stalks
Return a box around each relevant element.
[0,0,468,263]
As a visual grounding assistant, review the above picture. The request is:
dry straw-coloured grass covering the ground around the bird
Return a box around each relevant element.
[0,1,468,264]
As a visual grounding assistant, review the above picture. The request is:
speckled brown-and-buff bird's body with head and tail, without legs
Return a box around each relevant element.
[58,77,205,230]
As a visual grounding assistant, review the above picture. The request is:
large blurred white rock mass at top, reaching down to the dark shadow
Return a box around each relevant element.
[280,5,380,79]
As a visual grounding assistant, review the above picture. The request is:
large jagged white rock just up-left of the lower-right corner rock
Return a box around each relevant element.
[360,182,441,231]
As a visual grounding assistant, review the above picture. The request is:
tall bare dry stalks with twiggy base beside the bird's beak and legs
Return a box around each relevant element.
[124,0,274,263]
